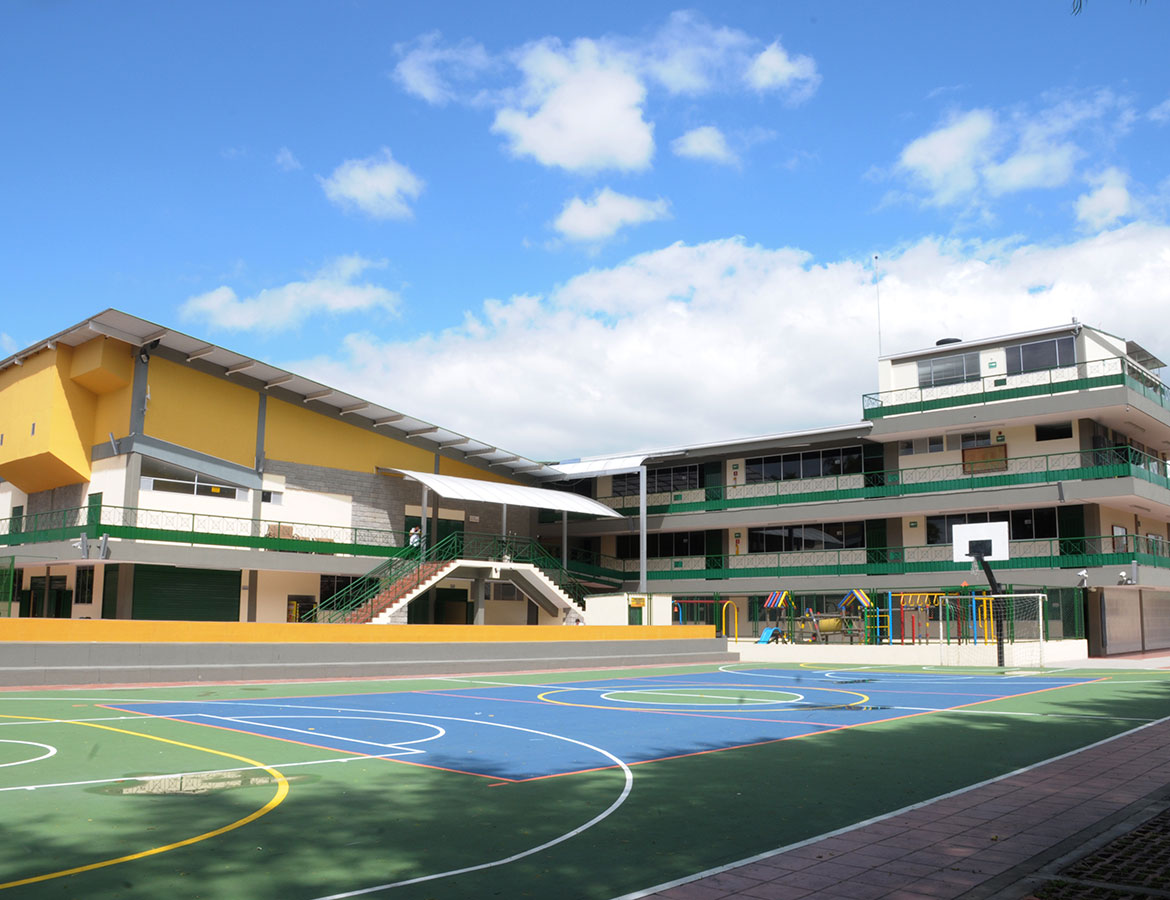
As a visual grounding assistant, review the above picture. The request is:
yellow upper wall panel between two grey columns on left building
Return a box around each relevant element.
[144,357,260,466]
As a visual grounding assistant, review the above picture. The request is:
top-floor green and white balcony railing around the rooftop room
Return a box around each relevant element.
[861,357,1170,419]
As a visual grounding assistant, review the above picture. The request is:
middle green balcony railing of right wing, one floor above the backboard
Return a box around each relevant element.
[598,447,1170,515]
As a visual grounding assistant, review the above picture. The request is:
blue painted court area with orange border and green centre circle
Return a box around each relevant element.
[106,667,1088,782]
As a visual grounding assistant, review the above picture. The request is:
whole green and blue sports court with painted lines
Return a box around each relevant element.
[0,662,1170,900]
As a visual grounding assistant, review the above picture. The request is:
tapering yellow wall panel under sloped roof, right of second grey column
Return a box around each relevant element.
[264,398,434,473]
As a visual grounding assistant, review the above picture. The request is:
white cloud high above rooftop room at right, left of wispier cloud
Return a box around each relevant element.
[897,109,996,206]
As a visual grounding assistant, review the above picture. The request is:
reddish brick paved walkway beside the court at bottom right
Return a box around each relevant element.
[627,721,1170,900]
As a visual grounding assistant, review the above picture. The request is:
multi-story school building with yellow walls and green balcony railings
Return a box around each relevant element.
[0,310,1170,653]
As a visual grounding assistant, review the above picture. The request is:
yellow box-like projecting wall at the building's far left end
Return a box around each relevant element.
[0,345,96,493]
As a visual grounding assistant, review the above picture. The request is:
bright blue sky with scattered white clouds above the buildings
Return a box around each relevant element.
[0,0,1170,459]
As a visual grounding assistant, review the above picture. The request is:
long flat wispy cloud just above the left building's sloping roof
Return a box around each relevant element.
[180,255,398,332]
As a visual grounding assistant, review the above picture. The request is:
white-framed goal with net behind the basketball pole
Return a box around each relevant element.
[938,593,1047,668]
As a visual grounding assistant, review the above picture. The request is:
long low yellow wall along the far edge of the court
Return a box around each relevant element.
[0,619,715,644]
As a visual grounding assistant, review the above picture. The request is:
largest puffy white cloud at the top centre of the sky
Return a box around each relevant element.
[491,39,654,172]
